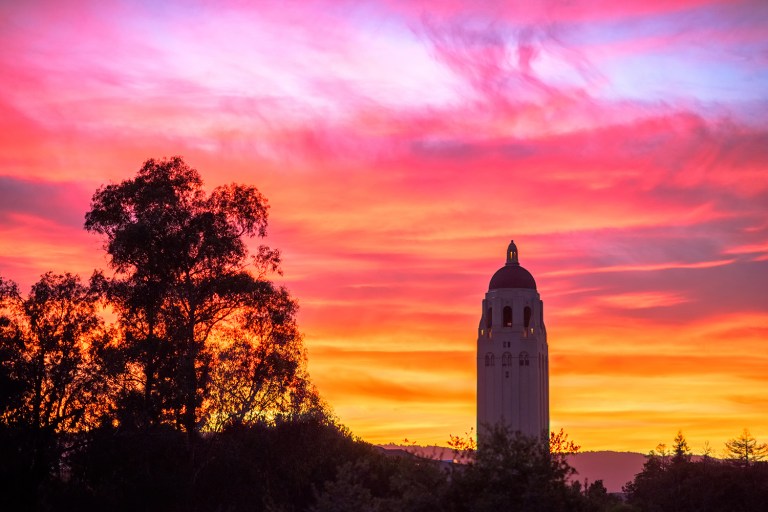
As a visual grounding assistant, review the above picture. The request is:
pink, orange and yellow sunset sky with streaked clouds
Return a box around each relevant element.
[0,0,768,452]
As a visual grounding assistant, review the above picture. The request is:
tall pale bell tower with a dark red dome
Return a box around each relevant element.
[477,241,549,442]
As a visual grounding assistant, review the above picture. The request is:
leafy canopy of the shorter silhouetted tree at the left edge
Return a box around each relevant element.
[0,272,104,433]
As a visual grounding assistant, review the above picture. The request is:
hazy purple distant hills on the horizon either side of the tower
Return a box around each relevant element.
[379,444,645,492]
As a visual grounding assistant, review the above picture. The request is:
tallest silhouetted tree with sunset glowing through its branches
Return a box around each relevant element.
[85,157,318,436]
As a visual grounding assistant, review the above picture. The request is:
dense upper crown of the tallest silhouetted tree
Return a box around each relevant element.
[85,157,277,279]
